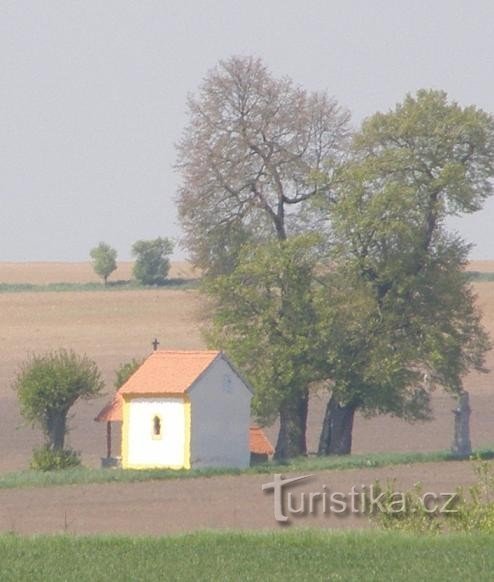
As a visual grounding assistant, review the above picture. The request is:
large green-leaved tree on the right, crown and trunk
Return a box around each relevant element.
[319,91,494,454]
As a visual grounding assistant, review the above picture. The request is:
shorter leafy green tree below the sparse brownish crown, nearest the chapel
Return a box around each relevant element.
[207,235,327,459]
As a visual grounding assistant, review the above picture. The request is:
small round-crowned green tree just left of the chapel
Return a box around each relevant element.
[13,349,104,451]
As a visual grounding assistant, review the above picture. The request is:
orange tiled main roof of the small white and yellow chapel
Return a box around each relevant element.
[118,350,221,394]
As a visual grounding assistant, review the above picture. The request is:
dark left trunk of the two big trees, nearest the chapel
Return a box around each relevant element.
[274,390,309,460]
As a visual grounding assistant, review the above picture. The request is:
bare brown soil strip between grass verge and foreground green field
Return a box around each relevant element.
[0,461,482,535]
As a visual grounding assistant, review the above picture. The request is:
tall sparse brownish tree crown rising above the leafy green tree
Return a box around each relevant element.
[177,57,349,454]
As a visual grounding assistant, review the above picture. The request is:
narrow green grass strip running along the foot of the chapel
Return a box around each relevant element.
[0,449,494,489]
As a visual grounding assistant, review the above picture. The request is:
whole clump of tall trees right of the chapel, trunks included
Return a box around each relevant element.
[178,58,494,457]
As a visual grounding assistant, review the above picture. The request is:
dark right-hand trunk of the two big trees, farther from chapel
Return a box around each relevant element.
[318,395,357,455]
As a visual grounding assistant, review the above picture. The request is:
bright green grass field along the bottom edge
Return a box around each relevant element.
[0,531,494,582]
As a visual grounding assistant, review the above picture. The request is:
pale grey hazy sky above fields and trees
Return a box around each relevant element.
[0,0,494,261]
